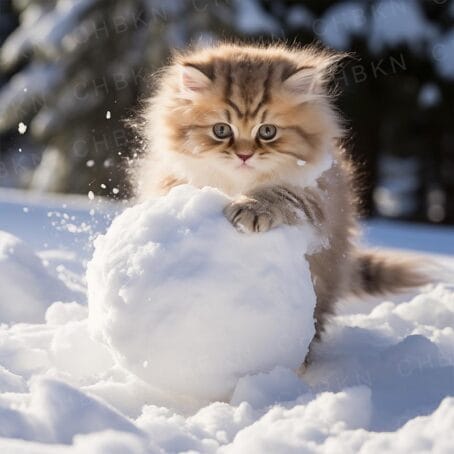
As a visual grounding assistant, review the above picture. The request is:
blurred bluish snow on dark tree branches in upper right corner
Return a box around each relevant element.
[314,0,454,80]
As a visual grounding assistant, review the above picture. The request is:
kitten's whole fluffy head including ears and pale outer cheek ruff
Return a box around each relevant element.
[145,44,342,192]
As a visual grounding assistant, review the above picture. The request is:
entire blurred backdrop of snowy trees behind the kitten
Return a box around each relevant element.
[0,0,454,224]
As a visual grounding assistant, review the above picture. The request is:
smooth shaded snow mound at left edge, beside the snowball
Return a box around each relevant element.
[0,231,68,323]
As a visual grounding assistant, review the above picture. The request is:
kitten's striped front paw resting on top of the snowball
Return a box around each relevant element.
[224,199,278,233]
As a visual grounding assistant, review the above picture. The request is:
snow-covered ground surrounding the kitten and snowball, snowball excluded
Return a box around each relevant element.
[0,186,454,454]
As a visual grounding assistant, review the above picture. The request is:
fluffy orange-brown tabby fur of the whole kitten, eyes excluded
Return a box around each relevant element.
[136,44,425,346]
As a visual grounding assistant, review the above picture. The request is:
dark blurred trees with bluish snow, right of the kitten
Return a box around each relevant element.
[247,0,454,222]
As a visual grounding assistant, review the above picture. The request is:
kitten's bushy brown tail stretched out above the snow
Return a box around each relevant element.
[350,250,437,295]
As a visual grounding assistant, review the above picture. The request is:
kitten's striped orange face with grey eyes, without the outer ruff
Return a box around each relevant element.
[153,47,338,192]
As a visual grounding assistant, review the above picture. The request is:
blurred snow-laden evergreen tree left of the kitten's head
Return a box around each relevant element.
[0,0,234,196]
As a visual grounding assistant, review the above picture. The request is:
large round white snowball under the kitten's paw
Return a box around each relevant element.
[87,186,315,401]
